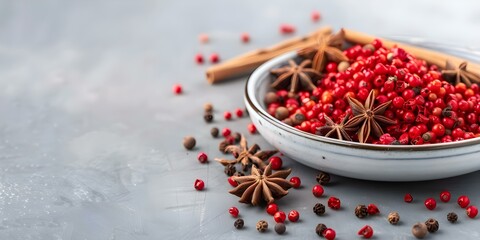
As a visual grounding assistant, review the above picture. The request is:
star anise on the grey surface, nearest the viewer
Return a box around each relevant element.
[229,164,292,205]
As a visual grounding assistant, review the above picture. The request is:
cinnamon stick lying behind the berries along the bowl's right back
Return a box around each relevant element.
[343,29,480,75]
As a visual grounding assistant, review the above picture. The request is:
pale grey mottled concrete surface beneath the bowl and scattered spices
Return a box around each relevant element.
[0,0,480,240]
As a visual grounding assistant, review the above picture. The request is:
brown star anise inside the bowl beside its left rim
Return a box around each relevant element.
[271,59,320,93]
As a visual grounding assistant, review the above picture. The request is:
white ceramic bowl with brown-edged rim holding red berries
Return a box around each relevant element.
[245,42,480,181]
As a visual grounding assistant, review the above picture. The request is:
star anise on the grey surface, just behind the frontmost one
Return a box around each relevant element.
[215,135,278,171]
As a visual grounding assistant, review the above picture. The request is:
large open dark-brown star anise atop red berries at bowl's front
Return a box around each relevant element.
[345,90,396,143]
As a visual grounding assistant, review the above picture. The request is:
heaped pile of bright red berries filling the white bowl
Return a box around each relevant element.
[267,40,480,145]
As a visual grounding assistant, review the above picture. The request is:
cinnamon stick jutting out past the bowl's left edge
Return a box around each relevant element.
[206,27,332,84]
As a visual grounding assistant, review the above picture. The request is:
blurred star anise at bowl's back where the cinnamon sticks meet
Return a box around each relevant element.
[298,29,348,72]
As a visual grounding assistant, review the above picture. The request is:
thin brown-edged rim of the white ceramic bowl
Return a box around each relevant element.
[245,51,480,151]
